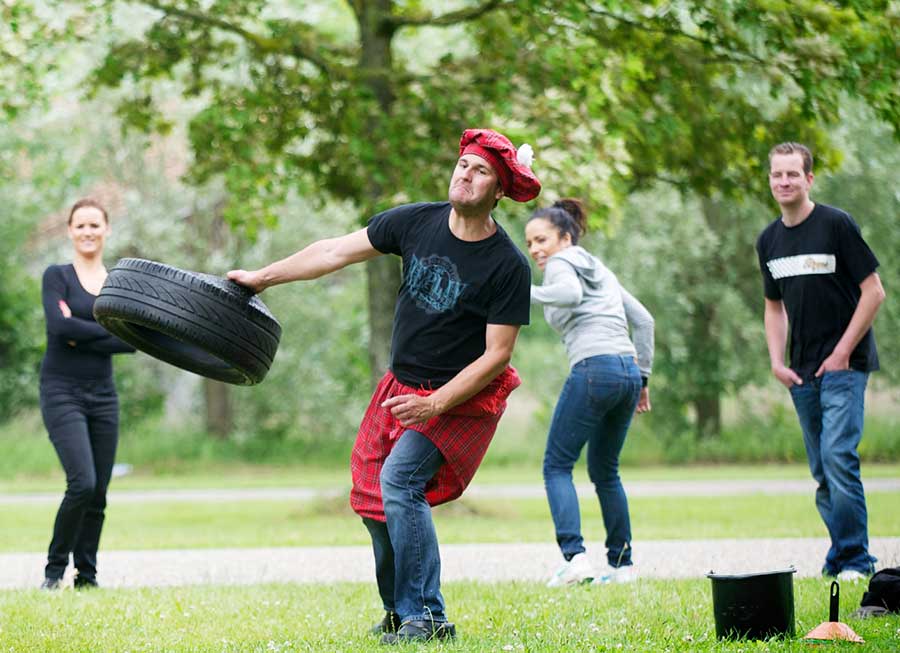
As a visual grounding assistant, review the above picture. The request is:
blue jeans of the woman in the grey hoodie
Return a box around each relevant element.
[544,356,641,567]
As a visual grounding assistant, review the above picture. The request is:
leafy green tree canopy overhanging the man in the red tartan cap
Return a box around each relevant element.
[72,0,900,232]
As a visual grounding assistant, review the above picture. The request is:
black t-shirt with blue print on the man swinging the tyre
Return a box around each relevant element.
[367,202,531,388]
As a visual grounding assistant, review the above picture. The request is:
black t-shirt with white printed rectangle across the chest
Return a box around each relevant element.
[756,204,878,379]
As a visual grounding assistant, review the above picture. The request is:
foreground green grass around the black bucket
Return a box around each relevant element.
[0,579,900,653]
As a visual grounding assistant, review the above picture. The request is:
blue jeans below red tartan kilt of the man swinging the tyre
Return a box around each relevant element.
[363,430,447,623]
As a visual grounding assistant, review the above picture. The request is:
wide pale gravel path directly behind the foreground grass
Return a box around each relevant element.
[0,537,900,589]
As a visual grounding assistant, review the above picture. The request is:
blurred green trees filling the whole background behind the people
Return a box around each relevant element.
[0,0,900,468]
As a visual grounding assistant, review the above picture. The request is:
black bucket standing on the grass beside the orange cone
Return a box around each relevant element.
[706,567,797,639]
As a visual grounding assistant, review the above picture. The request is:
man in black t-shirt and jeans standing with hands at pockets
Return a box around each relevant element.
[756,143,885,580]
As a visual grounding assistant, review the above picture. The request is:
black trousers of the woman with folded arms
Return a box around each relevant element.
[40,376,119,579]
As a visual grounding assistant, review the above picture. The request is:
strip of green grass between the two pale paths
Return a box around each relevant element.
[0,493,900,552]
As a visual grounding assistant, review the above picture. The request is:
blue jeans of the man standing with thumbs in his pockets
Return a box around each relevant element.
[791,370,876,576]
